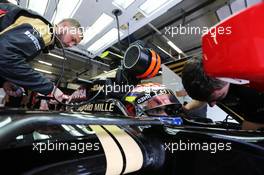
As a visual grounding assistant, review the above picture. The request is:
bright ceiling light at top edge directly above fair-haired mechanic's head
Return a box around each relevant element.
[52,0,83,24]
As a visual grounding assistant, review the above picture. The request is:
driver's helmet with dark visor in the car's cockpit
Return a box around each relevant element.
[125,83,182,117]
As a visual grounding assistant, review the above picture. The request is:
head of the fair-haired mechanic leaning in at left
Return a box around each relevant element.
[56,18,83,47]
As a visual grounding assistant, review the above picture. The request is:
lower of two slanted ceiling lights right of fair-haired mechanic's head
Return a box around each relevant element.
[87,28,123,54]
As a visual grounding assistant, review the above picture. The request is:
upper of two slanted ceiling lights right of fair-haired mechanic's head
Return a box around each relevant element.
[81,13,114,44]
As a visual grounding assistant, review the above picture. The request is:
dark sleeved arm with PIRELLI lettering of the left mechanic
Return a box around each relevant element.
[0,24,54,95]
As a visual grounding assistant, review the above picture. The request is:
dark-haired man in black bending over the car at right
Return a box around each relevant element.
[182,58,264,130]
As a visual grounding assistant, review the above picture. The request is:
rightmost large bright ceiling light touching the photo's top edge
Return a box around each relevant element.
[139,0,182,15]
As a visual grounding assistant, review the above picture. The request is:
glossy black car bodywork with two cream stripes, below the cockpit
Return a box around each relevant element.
[0,110,264,175]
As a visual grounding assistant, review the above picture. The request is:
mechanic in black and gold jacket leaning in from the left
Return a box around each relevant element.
[0,3,83,101]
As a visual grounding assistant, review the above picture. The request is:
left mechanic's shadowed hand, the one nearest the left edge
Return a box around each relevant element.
[3,81,25,97]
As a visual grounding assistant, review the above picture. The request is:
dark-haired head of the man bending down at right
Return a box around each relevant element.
[182,58,229,106]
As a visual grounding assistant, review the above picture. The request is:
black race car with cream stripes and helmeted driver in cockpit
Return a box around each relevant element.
[0,42,264,175]
